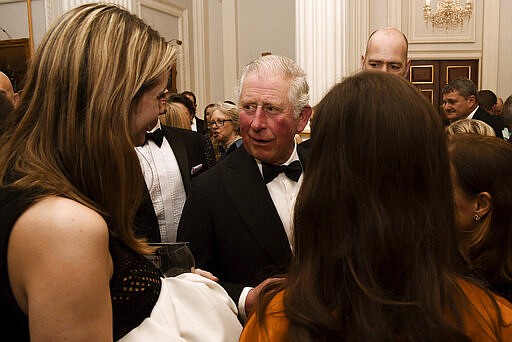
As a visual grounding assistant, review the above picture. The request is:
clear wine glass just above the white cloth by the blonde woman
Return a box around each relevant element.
[148,242,196,277]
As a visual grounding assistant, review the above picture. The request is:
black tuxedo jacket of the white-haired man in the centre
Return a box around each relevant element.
[178,146,307,303]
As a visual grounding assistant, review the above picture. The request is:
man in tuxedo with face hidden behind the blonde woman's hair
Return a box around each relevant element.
[135,91,215,242]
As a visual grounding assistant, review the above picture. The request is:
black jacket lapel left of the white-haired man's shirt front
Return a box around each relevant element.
[221,148,291,262]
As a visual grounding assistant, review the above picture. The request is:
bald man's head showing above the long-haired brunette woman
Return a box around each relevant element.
[361,27,411,77]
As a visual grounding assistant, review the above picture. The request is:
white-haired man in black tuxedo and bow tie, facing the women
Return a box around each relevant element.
[178,55,311,320]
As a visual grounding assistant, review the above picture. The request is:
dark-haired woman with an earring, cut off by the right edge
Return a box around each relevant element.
[448,133,512,301]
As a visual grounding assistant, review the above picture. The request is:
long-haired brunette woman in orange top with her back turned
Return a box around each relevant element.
[241,72,512,342]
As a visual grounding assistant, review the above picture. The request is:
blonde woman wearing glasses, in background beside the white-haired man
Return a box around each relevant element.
[209,102,242,159]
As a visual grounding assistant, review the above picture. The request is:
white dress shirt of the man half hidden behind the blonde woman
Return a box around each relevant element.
[136,121,186,242]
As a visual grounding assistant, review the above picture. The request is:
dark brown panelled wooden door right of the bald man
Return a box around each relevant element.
[409,59,479,110]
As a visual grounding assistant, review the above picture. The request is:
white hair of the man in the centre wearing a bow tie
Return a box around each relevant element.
[235,55,309,118]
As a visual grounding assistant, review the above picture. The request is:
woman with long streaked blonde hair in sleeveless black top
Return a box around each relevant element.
[0,4,175,341]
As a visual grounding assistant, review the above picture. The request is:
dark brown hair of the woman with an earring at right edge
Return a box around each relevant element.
[449,134,512,286]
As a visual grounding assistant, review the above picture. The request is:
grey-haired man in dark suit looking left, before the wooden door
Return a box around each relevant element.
[442,77,505,139]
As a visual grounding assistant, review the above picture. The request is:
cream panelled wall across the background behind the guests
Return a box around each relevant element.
[0,0,512,103]
